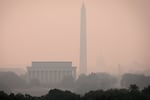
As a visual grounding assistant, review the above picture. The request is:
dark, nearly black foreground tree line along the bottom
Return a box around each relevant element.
[0,84,150,100]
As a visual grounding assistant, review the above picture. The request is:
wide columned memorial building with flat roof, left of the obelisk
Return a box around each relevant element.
[27,62,76,84]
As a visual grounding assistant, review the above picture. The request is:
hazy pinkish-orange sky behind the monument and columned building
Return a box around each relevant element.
[0,0,150,72]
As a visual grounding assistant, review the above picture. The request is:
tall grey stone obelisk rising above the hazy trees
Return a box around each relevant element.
[79,2,87,75]
